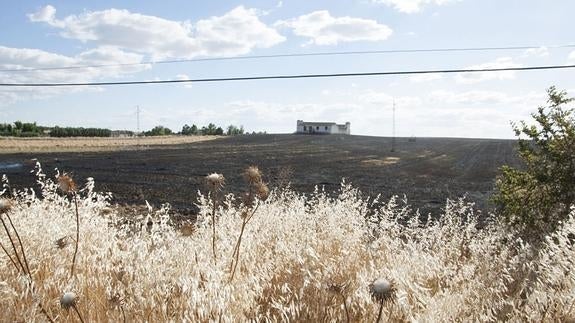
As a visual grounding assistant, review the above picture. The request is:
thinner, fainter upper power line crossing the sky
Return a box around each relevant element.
[0,44,575,73]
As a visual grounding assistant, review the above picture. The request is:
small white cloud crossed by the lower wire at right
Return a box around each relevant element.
[455,57,523,84]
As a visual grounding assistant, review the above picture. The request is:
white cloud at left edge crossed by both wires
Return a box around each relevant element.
[0,46,149,105]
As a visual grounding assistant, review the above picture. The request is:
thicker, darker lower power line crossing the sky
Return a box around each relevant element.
[0,65,575,87]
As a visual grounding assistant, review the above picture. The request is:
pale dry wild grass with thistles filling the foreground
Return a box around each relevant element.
[0,166,575,322]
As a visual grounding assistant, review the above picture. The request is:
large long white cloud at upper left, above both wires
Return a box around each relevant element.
[28,6,285,59]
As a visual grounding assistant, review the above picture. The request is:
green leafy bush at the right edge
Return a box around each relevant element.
[493,87,575,237]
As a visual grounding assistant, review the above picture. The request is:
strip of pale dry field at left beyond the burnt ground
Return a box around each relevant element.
[0,136,217,153]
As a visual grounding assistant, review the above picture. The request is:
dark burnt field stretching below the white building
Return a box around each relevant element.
[0,135,518,218]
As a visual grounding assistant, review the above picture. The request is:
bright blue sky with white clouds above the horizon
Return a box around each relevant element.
[0,0,575,138]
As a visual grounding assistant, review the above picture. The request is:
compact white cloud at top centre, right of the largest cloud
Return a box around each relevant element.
[275,10,393,45]
